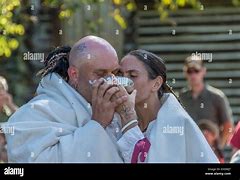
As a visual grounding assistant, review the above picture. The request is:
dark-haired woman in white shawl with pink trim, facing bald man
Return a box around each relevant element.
[118,50,218,163]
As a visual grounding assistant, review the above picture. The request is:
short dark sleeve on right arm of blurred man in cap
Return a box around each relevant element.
[216,95,232,125]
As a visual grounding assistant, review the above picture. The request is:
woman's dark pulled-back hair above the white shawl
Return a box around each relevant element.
[128,49,178,99]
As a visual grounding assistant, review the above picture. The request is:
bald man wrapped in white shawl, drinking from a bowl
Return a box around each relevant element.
[5,36,136,162]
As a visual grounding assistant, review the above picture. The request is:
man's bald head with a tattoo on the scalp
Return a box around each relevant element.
[68,36,119,102]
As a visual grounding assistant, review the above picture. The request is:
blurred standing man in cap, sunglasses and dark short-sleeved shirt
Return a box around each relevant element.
[179,56,233,148]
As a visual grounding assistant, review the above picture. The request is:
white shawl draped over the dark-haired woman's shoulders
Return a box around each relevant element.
[146,93,218,163]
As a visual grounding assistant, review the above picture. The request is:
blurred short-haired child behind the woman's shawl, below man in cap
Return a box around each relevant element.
[198,119,224,163]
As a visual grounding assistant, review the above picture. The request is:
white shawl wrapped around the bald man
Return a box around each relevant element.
[6,73,122,162]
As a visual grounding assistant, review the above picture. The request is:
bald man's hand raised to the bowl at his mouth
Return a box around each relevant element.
[92,78,128,128]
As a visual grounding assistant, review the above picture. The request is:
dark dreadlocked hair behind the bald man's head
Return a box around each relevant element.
[37,46,71,81]
